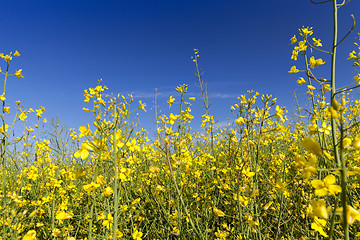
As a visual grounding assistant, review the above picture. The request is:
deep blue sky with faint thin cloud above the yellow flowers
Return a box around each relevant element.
[0,0,360,134]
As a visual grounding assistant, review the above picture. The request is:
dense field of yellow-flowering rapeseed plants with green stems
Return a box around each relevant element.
[0,0,360,240]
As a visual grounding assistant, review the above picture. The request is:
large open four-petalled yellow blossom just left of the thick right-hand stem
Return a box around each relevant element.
[311,174,341,197]
